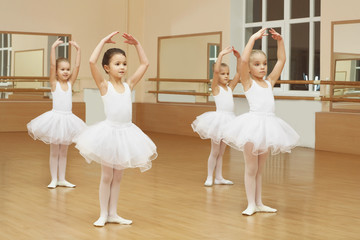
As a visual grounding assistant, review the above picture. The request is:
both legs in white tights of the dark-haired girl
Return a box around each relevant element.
[94,165,132,227]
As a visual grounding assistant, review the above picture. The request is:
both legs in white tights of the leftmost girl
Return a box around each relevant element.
[48,144,75,188]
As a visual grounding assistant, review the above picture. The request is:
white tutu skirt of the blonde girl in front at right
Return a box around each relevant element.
[224,112,300,155]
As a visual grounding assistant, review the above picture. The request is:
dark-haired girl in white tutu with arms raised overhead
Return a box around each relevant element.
[74,32,157,227]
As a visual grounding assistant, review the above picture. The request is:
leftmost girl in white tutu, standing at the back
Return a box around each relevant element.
[27,38,86,188]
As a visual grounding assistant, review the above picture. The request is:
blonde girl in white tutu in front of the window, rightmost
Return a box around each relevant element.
[224,28,299,215]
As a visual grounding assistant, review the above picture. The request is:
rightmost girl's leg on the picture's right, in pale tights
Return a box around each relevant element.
[255,152,277,212]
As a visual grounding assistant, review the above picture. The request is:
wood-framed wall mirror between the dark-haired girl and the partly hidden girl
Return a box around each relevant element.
[157,32,222,103]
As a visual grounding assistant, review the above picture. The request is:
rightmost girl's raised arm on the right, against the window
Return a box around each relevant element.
[267,29,286,87]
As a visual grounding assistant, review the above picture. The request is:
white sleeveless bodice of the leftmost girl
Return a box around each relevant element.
[51,81,72,112]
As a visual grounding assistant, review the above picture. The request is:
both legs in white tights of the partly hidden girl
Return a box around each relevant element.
[205,140,233,186]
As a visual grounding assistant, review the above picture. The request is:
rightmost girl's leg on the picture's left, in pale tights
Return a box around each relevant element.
[242,143,258,216]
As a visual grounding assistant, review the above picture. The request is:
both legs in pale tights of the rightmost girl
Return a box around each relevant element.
[243,143,276,215]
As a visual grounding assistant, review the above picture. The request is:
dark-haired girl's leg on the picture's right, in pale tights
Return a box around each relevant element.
[107,169,132,224]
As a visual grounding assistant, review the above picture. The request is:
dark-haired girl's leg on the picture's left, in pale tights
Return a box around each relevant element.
[94,165,113,227]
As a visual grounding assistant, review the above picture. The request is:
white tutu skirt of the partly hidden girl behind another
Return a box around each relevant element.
[191,111,235,144]
